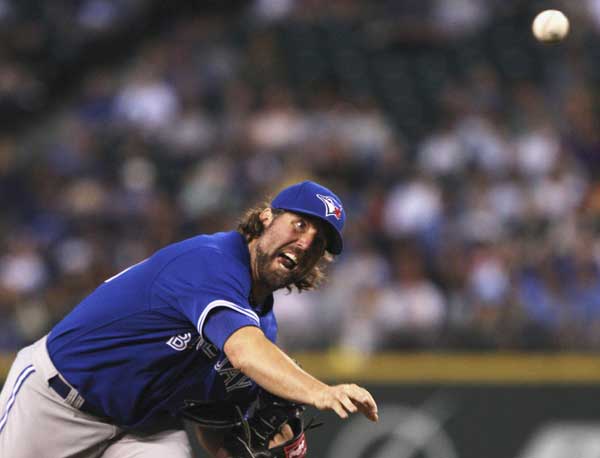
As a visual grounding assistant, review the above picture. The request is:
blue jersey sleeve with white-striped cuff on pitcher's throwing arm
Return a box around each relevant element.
[154,248,260,348]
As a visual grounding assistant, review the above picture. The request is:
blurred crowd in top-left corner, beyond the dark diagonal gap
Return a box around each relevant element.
[0,0,154,132]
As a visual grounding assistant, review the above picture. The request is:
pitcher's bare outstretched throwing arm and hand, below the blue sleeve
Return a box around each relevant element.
[224,326,378,421]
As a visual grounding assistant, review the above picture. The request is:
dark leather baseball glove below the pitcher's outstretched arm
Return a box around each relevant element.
[181,392,320,458]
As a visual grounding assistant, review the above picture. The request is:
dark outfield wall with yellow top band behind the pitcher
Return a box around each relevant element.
[0,353,600,458]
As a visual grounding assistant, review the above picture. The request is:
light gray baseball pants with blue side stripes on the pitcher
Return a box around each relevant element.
[0,337,192,458]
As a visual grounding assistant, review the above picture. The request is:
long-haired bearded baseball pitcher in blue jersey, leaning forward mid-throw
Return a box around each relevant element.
[0,181,378,458]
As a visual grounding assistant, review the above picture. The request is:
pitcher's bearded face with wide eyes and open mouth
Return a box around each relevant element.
[254,211,326,291]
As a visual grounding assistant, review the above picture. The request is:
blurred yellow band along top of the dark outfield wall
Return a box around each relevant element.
[0,351,600,384]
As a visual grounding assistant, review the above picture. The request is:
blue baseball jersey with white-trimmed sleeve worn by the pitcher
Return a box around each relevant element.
[47,232,277,427]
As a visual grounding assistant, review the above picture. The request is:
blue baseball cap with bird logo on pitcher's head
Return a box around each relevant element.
[271,181,346,254]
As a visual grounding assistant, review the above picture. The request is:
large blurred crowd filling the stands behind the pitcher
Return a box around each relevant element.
[0,0,600,353]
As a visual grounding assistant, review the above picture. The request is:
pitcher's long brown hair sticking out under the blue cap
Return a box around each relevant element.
[237,202,333,292]
